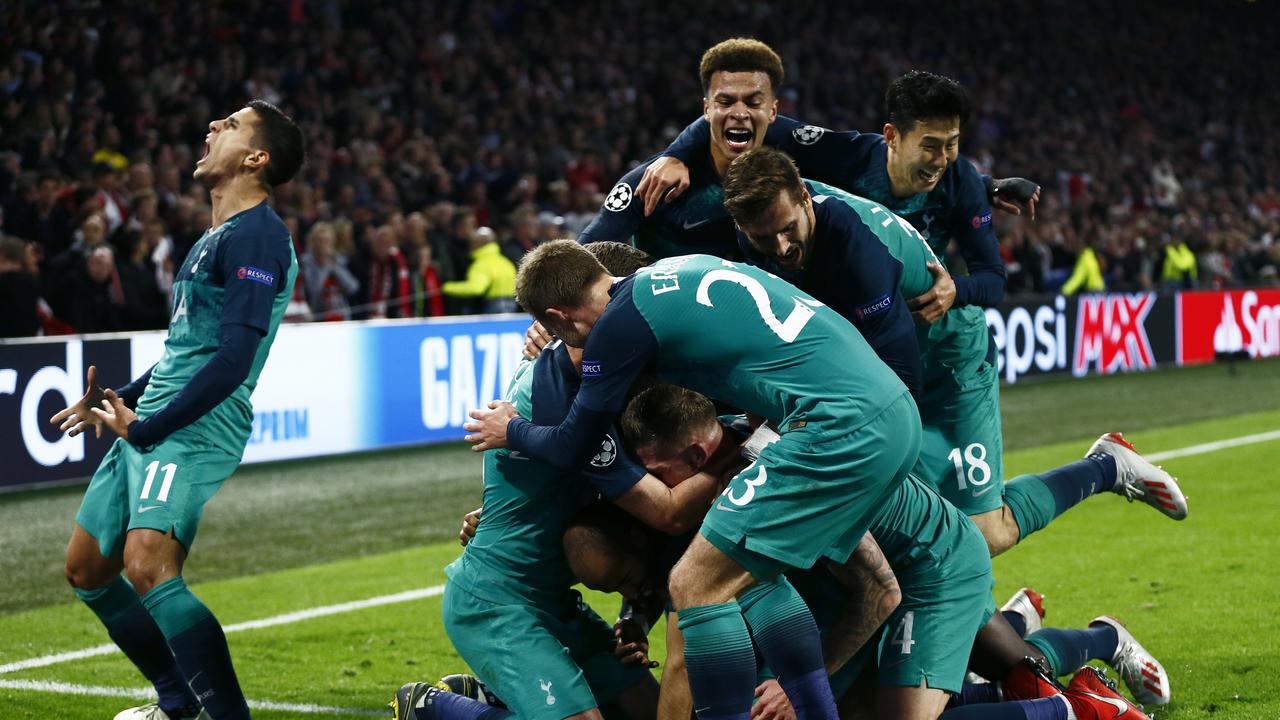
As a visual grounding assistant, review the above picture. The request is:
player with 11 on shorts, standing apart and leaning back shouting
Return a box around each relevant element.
[52,100,303,720]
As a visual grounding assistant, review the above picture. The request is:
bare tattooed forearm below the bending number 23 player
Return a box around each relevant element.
[822,533,902,674]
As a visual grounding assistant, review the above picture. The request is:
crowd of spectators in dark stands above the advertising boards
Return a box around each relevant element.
[0,0,1280,337]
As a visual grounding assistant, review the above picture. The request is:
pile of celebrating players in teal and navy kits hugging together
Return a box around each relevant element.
[424,40,1187,720]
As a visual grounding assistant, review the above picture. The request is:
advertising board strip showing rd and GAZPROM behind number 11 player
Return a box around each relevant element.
[0,315,529,488]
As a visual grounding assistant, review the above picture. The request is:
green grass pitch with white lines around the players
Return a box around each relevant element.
[0,361,1280,720]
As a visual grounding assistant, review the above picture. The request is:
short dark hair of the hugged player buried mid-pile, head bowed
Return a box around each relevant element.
[620,383,716,450]
